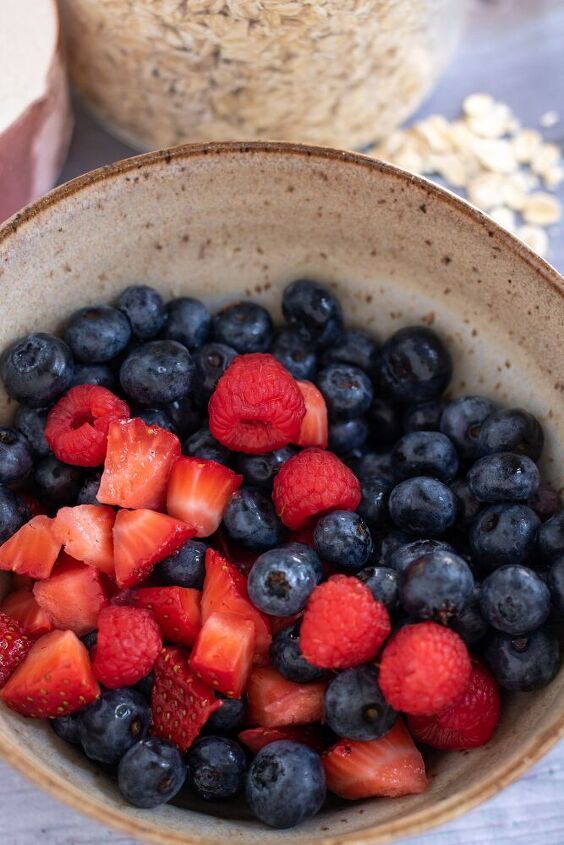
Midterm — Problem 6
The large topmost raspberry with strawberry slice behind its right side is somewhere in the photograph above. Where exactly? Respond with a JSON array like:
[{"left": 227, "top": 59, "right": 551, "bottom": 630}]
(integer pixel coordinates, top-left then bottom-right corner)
[{"left": 208, "top": 352, "right": 305, "bottom": 454}]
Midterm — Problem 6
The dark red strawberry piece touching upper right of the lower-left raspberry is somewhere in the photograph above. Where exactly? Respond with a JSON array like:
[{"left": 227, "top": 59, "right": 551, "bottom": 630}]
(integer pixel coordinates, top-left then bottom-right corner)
[{"left": 134, "top": 587, "right": 202, "bottom": 646}]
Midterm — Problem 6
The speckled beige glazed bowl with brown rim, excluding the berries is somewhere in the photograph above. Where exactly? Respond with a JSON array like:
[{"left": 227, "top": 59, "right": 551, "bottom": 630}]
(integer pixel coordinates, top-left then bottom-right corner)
[{"left": 0, "top": 144, "right": 564, "bottom": 845}]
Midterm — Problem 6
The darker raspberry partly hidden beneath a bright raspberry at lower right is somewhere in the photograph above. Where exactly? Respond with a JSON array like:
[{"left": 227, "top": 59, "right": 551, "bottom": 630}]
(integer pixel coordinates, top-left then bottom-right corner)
[{"left": 408, "top": 660, "right": 501, "bottom": 751}]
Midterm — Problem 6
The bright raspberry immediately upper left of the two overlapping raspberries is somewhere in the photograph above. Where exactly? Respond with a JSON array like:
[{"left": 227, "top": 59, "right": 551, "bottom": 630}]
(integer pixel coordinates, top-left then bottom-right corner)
[{"left": 300, "top": 575, "right": 390, "bottom": 669}]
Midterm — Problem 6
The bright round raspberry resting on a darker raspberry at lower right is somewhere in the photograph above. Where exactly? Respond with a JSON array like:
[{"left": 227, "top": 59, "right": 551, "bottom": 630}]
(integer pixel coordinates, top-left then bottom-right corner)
[{"left": 380, "top": 622, "right": 472, "bottom": 716}]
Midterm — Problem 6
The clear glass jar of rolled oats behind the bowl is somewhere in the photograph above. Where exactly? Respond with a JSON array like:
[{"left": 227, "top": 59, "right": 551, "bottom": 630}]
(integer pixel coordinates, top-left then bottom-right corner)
[{"left": 60, "top": 0, "right": 464, "bottom": 149}]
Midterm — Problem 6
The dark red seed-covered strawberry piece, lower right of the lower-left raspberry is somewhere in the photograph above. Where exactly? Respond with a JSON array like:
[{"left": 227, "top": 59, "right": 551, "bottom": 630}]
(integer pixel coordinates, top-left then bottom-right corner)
[{"left": 151, "top": 648, "right": 223, "bottom": 752}]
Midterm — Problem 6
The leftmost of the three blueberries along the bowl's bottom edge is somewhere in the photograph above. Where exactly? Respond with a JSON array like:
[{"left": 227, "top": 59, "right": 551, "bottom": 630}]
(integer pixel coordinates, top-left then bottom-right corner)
[{"left": 118, "top": 737, "right": 186, "bottom": 810}]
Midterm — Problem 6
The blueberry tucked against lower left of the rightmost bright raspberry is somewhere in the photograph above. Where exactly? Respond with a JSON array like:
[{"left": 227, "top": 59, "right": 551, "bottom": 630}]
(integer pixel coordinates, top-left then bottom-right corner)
[{"left": 324, "top": 665, "right": 397, "bottom": 742}]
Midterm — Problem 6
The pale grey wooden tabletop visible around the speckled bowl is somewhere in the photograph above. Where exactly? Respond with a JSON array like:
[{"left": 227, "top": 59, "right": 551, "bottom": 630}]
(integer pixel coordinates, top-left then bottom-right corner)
[{"left": 0, "top": 0, "right": 564, "bottom": 845}]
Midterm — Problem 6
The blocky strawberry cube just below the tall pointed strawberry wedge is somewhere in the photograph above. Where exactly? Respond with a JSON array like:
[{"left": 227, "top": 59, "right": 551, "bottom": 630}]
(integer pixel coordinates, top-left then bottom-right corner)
[{"left": 190, "top": 613, "right": 255, "bottom": 698}]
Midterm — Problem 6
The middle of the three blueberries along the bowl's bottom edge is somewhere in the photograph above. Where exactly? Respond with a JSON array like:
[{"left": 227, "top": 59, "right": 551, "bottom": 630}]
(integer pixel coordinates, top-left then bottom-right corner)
[{"left": 187, "top": 736, "right": 247, "bottom": 800}]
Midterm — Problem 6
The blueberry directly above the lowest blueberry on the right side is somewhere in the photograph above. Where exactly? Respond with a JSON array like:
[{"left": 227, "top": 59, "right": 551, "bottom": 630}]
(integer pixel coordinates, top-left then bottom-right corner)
[{"left": 480, "top": 564, "right": 550, "bottom": 636}]
